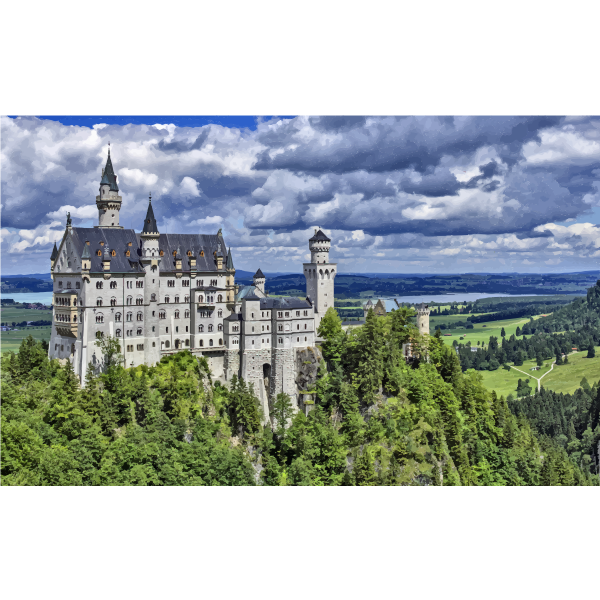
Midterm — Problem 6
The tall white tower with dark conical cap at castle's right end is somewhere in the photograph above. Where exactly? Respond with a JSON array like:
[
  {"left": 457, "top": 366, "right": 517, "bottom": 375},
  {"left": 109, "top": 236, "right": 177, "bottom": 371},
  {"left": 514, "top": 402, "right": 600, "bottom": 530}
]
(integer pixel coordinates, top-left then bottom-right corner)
[{"left": 303, "top": 229, "right": 337, "bottom": 329}]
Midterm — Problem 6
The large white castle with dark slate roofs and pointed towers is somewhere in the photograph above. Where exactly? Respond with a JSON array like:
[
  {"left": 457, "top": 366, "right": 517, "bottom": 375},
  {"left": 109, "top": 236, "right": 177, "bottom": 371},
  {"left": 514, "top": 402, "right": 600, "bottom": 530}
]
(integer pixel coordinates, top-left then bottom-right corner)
[{"left": 48, "top": 149, "right": 337, "bottom": 414}]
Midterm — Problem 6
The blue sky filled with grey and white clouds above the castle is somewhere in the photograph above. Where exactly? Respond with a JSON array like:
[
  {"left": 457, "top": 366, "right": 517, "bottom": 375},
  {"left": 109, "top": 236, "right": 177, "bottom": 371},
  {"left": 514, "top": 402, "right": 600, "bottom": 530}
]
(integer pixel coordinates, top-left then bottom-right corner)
[{"left": 0, "top": 115, "right": 600, "bottom": 275}]
